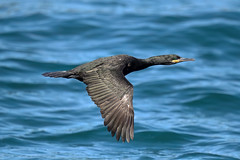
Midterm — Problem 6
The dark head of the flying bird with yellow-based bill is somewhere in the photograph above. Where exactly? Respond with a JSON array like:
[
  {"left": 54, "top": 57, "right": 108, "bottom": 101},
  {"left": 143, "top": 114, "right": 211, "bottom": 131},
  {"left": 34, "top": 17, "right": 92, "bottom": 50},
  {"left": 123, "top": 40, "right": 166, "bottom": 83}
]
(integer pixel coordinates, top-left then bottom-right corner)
[{"left": 147, "top": 54, "right": 195, "bottom": 65}]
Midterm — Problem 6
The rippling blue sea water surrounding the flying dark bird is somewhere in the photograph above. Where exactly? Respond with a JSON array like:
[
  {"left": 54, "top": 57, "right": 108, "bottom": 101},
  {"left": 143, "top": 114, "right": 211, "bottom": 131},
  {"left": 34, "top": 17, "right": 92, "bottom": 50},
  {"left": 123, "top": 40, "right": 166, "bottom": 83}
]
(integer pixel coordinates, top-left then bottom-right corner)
[{"left": 0, "top": 0, "right": 240, "bottom": 160}]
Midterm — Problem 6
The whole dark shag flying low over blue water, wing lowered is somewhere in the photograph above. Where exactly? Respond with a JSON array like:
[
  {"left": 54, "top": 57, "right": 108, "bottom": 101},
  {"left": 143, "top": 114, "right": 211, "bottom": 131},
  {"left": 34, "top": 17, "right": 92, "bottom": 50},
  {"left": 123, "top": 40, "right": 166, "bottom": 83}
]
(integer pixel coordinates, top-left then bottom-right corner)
[{"left": 43, "top": 54, "right": 194, "bottom": 142}]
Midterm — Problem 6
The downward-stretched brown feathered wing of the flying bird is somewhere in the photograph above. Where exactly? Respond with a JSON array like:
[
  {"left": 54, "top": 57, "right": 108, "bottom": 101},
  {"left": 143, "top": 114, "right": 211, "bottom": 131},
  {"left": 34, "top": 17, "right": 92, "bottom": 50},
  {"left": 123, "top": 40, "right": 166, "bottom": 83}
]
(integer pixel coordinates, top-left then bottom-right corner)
[{"left": 83, "top": 68, "right": 134, "bottom": 142}]
